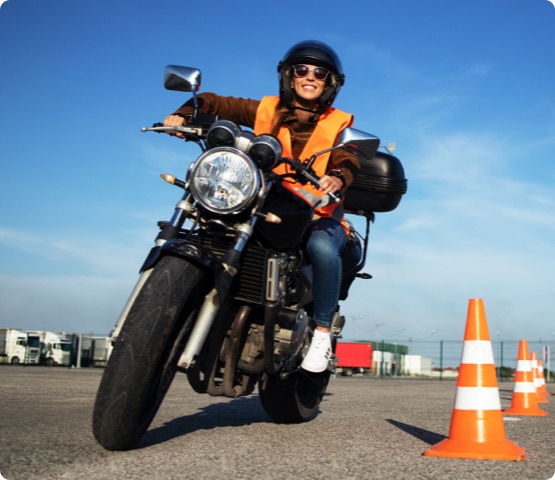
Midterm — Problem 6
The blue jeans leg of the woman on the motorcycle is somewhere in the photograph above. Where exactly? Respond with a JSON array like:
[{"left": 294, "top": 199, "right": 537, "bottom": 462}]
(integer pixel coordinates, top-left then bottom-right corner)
[{"left": 306, "top": 218, "right": 347, "bottom": 327}]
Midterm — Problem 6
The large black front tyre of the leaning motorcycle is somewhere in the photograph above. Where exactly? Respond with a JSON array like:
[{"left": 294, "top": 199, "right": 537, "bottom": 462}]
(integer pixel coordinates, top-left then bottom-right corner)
[{"left": 93, "top": 256, "right": 207, "bottom": 450}]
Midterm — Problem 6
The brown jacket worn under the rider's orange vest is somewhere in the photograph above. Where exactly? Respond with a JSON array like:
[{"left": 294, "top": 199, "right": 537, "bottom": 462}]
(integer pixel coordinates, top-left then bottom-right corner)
[{"left": 174, "top": 93, "right": 360, "bottom": 192}]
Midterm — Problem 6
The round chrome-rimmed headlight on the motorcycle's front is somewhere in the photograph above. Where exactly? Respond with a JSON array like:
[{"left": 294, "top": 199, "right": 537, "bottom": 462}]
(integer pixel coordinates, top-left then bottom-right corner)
[{"left": 189, "top": 147, "right": 261, "bottom": 213}]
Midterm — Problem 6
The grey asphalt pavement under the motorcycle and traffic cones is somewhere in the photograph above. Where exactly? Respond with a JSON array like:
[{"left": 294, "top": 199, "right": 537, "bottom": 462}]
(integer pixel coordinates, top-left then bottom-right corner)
[{"left": 0, "top": 365, "right": 555, "bottom": 480}]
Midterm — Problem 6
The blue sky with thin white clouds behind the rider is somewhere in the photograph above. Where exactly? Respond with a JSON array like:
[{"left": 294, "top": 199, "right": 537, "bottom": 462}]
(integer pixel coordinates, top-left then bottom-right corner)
[{"left": 0, "top": 0, "right": 555, "bottom": 343}]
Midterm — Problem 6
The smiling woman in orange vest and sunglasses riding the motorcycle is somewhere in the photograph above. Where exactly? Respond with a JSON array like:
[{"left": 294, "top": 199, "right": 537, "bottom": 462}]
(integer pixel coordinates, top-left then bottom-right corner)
[{"left": 164, "top": 40, "right": 360, "bottom": 373}]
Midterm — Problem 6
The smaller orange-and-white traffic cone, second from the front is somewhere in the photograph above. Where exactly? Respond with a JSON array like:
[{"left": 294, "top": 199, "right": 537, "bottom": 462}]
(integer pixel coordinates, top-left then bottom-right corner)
[{"left": 503, "top": 340, "right": 547, "bottom": 417}]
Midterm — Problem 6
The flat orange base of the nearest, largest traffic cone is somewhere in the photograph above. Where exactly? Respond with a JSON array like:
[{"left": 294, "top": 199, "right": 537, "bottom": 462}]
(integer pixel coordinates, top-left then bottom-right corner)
[{"left": 422, "top": 438, "right": 526, "bottom": 462}]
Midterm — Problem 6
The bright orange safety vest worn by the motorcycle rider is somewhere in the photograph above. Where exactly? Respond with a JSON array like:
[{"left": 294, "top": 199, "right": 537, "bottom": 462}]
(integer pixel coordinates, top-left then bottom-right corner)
[{"left": 254, "top": 97, "right": 353, "bottom": 228}]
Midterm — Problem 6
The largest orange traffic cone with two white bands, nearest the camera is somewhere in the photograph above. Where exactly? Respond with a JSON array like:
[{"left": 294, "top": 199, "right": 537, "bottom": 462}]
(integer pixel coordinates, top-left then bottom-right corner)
[{"left": 423, "top": 299, "right": 526, "bottom": 460}]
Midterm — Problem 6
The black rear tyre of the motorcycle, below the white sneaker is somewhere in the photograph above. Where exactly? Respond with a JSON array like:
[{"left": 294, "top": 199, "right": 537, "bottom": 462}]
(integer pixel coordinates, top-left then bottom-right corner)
[{"left": 258, "top": 370, "right": 330, "bottom": 423}]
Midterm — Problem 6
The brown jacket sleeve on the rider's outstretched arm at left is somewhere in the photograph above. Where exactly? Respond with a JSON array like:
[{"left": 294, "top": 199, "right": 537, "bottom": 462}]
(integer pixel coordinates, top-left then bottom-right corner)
[{"left": 174, "top": 93, "right": 260, "bottom": 128}]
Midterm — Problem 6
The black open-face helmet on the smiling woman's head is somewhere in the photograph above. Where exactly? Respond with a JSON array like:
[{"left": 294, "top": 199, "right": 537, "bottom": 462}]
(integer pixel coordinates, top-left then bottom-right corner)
[{"left": 278, "top": 40, "right": 345, "bottom": 113}]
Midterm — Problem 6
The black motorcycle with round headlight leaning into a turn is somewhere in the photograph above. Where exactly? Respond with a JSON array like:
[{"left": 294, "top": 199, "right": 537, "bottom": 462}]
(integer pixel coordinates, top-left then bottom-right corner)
[{"left": 93, "top": 65, "right": 406, "bottom": 450}]
